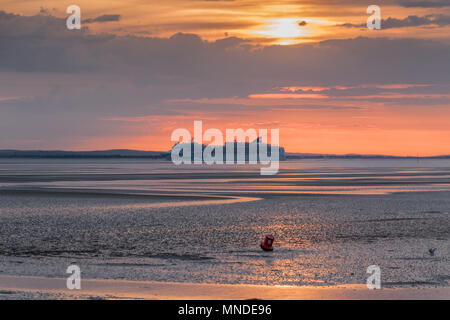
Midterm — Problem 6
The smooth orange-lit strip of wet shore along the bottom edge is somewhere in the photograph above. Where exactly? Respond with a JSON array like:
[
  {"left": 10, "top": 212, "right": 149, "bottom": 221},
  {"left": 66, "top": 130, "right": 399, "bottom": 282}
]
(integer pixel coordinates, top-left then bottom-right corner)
[{"left": 0, "top": 275, "right": 450, "bottom": 300}]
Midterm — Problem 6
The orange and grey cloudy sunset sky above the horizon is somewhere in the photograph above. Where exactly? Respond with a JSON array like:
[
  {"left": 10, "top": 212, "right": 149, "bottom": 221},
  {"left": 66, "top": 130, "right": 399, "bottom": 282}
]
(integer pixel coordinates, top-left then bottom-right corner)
[{"left": 0, "top": 0, "right": 450, "bottom": 156}]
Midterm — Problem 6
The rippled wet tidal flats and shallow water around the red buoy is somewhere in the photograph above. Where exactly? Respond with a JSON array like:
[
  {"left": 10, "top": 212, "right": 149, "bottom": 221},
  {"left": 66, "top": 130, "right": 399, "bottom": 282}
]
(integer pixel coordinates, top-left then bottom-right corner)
[{"left": 0, "top": 159, "right": 450, "bottom": 286}]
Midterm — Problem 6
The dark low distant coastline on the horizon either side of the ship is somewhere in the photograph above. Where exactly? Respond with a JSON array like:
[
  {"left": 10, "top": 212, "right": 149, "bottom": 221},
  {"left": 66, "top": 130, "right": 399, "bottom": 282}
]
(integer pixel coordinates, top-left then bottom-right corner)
[{"left": 0, "top": 149, "right": 450, "bottom": 160}]
